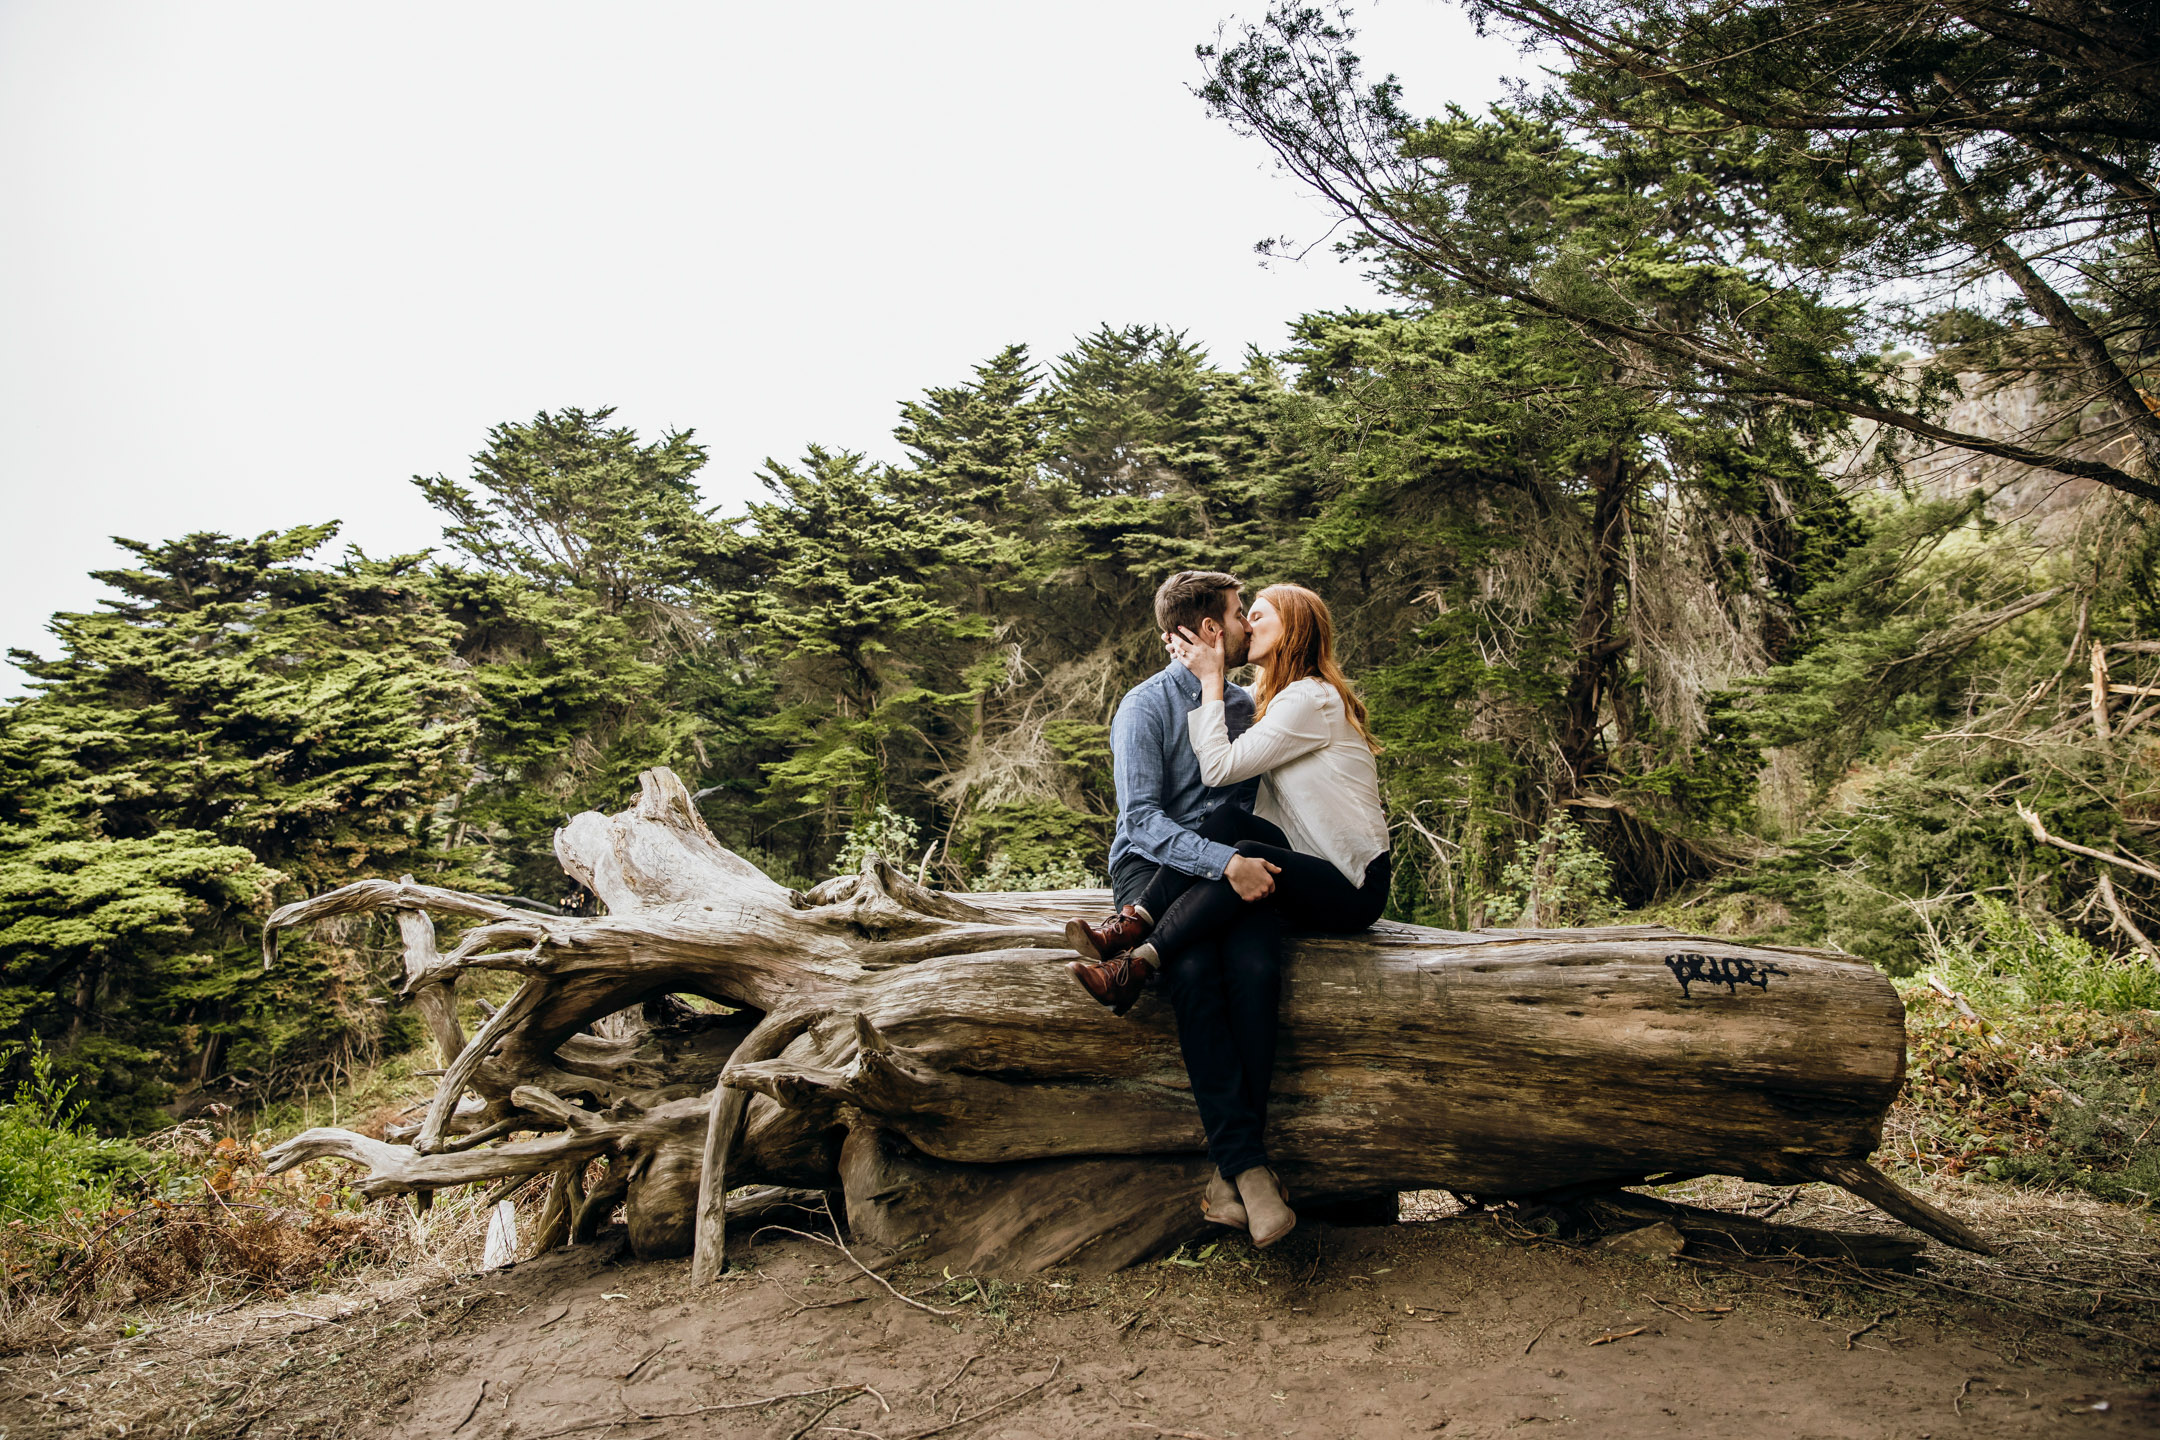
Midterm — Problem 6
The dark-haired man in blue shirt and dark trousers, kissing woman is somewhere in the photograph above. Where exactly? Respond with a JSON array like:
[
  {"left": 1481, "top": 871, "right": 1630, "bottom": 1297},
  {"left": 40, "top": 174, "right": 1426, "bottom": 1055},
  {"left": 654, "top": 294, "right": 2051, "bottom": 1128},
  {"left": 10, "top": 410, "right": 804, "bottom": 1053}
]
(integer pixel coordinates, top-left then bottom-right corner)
[{"left": 1065, "top": 570, "right": 1296, "bottom": 1244}]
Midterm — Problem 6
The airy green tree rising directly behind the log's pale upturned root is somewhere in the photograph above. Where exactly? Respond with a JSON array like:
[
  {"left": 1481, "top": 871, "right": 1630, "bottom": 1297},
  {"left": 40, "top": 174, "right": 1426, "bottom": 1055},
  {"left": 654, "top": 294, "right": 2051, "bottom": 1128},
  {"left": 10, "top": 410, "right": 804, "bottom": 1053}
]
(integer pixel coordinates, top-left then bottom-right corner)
[{"left": 415, "top": 408, "right": 743, "bottom": 900}]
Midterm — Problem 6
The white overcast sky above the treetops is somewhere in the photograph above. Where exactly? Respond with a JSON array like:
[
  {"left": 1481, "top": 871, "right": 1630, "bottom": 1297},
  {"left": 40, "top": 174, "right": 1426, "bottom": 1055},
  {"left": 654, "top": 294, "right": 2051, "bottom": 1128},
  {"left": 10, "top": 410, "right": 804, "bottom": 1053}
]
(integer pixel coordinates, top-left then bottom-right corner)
[{"left": 0, "top": 0, "right": 1523, "bottom": 693}]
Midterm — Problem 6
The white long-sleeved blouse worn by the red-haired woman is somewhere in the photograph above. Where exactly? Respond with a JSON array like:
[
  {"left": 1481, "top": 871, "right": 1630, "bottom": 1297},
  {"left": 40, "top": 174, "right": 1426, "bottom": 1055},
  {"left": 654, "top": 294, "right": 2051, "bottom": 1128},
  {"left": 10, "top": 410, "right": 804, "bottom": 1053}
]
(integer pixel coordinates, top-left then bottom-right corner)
[{"left": 1186, "top": 678, "right": 1387, "bottom": 885}]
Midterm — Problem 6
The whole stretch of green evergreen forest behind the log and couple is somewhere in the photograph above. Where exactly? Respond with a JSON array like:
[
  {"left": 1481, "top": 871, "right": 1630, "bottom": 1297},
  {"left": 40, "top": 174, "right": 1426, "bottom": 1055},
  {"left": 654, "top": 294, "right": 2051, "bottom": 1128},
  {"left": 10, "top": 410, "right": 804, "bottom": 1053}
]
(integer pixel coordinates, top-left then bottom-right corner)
[{"left": 0, "top": 0, "right": 2160, "bottom": 1129}]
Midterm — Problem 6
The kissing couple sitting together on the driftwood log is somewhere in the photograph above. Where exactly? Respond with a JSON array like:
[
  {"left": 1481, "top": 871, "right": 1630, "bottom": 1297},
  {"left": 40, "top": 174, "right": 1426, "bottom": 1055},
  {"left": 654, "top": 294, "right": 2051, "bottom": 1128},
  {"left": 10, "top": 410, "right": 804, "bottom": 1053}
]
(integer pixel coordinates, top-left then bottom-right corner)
[{"left": 1065, "top": 570, "right": 1391, "bottom": 1248}]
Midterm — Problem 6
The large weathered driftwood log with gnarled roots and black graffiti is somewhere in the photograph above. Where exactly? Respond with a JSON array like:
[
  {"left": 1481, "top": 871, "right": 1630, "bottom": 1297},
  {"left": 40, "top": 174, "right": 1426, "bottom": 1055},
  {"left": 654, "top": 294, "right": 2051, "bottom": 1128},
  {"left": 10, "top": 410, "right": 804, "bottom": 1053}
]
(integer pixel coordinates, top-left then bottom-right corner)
[{"left": 264, "top": 771, "right": 1985, "bottom": 1276}]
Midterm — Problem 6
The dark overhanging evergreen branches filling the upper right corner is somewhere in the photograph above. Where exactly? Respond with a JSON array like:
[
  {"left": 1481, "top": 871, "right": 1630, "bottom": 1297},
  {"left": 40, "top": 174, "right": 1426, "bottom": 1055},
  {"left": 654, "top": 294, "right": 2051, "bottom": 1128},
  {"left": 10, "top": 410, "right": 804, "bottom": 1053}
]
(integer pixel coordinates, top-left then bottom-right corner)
[{"left": 1201, "top": 0, "right": 2160, "bottom": 499}]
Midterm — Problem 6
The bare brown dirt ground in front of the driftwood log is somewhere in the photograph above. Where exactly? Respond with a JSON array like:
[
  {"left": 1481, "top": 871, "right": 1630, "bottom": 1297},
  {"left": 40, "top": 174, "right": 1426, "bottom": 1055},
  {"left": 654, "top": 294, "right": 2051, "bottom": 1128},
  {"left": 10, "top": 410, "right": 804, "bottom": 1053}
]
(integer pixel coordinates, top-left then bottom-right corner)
[{"left": 0, "top": 1181, "right": 2160, "bottom": 1440}]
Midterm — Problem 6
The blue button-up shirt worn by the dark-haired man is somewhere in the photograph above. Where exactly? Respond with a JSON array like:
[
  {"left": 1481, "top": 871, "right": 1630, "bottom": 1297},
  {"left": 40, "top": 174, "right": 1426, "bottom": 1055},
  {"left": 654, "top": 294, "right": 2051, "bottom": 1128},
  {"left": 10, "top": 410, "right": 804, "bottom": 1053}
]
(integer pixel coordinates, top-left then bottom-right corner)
[{"left": 1110, "top": 661, "right": 1259, "bottom": 881}]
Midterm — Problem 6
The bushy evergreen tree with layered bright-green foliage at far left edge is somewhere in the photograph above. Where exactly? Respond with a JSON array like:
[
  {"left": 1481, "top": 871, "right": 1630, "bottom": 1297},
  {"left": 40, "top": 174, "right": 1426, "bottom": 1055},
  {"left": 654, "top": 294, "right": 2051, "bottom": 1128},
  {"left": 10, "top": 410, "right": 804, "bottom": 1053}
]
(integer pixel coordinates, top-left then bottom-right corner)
[{"left": 0, "top": 525, "right": 471, "bottom": 1125}]
